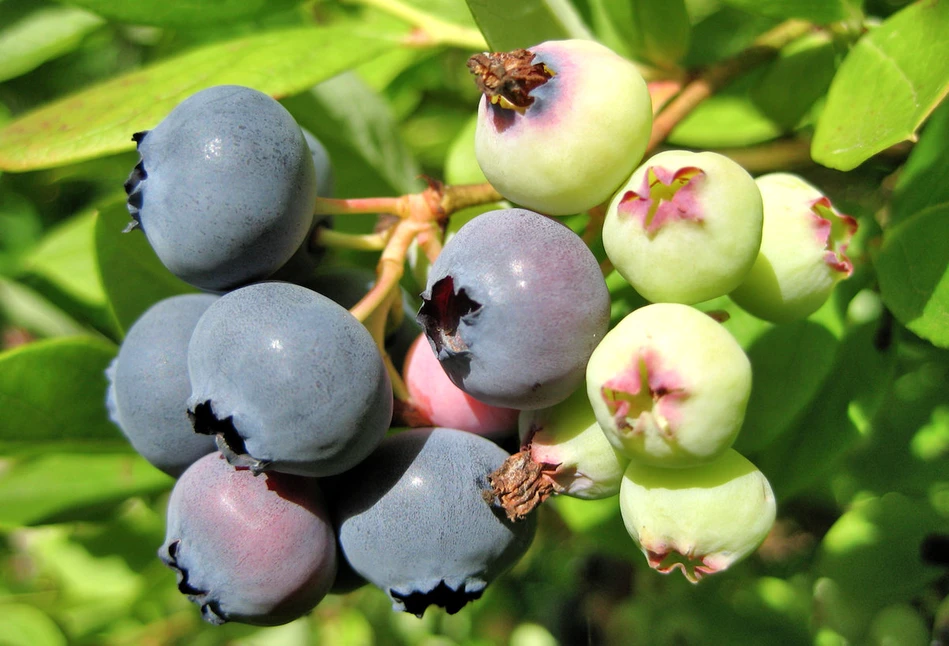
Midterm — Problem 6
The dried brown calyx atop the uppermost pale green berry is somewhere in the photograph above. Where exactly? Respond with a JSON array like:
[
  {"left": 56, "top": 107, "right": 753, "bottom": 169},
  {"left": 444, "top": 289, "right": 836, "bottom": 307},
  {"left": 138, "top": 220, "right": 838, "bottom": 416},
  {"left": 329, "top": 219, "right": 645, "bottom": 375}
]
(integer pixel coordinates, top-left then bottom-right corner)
[{"left": 468, "top": 49, "right": 554, "bottom": 112}]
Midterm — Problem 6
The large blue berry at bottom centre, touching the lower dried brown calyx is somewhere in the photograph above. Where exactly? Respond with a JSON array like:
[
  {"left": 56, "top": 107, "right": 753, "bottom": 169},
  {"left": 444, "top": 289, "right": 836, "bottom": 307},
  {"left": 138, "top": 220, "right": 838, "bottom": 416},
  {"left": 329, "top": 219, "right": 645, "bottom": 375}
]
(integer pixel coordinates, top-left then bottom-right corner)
[{"left": 334, "top": 428, "right": 536, "bottom": 616}]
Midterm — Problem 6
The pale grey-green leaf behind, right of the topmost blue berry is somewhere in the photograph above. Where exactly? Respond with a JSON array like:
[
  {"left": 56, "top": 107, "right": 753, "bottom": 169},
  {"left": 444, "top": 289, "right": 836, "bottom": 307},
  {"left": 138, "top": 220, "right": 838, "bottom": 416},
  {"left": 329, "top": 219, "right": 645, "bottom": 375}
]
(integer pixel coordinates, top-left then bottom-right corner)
[{"left": 284, "top": 73, "right": 422, "bottom": 197}]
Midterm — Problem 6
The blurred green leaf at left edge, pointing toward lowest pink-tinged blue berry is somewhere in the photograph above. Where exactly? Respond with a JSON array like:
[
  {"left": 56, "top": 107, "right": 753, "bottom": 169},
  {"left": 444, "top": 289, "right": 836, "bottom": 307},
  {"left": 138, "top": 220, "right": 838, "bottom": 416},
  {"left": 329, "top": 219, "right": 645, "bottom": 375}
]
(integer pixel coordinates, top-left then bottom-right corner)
[{"left": 0, "top": 453, "right": 173, "bottom": 528}]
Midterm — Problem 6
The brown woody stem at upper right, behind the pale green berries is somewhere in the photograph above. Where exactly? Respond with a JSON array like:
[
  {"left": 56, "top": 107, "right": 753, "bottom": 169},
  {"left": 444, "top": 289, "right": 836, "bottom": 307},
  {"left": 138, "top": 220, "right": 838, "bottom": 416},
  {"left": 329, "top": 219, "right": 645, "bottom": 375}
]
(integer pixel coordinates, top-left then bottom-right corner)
[{"left": 646, "top": 20, "right": 813, "bottom": 154}]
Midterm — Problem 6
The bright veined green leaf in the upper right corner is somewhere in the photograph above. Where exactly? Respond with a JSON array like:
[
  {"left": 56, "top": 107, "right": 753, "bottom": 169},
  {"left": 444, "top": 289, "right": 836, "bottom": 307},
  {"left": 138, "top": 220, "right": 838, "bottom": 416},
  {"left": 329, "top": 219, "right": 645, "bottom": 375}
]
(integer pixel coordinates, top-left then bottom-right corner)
[{"left": 811, "top": 0, "right": 949, "bottom": 170}]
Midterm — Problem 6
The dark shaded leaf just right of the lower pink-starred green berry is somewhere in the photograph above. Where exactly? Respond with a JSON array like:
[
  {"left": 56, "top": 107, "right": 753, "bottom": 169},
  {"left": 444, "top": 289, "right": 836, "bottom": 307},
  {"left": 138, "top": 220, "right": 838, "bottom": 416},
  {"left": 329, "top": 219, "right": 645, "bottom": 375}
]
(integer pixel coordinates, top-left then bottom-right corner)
[{"left": 735, "top": 320, "right": 837, "bottom": 454}]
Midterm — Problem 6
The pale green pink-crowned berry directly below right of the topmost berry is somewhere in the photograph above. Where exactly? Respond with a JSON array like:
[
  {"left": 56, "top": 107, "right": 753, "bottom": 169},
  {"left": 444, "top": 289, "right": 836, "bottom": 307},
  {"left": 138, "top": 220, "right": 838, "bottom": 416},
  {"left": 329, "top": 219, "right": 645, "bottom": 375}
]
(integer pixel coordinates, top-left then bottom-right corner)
[{"left": 603, "top": 150, "right": 762, "bottom": 304}]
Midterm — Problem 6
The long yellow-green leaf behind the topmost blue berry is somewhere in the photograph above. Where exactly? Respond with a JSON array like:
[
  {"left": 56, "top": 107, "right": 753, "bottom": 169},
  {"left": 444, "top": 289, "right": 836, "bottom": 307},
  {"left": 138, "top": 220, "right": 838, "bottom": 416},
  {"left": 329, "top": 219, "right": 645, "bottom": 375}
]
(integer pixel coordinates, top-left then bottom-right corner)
[{"left": 0, "top": 24, "right": 399, "bottom": 171}]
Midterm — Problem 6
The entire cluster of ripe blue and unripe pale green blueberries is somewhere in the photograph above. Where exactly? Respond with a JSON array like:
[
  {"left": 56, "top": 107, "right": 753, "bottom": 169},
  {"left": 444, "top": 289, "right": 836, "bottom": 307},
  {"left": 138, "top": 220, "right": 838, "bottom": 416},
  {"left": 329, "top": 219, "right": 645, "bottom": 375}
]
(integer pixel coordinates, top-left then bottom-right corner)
[{"left": 106, "top": 33, "right": 856, "bottom": 625}]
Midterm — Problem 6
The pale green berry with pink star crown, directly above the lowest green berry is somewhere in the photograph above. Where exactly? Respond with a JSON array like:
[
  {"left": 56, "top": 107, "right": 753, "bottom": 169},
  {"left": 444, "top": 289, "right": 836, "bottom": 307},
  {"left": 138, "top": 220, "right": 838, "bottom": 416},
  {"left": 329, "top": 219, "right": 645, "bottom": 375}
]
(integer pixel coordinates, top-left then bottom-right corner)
[{"left": 587, "top": 303, "right": 751, "bottom": 467}]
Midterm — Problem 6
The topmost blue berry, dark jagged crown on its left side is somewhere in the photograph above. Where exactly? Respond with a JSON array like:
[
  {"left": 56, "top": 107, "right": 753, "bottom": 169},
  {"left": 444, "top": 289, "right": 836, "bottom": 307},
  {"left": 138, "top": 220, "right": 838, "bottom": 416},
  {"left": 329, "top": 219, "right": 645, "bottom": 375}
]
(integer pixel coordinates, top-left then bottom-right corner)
[{"left": 125, "top": 85, "right": 317, "bottom": 291}]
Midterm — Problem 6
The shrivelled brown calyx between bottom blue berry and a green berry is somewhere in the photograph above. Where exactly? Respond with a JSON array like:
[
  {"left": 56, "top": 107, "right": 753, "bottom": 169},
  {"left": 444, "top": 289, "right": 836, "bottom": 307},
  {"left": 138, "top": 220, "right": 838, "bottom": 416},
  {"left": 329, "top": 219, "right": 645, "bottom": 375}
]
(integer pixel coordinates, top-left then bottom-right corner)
[{"left": 488, "top": 445, "right": 563, "bottom": 522}]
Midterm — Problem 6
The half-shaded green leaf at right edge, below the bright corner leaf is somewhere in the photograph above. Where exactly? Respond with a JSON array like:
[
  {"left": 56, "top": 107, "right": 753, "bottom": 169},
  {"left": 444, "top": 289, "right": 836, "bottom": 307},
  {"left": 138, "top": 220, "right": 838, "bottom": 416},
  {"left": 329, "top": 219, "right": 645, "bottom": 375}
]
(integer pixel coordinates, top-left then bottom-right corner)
[{"left": 874, "top": 206, "right": 949, "bottom": 348}]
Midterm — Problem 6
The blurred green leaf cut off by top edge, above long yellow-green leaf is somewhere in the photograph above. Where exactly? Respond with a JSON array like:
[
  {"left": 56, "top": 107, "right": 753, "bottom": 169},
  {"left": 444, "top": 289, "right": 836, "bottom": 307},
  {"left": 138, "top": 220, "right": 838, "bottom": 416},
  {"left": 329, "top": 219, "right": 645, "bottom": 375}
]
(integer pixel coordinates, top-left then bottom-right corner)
[{"left": 52, "top": 0, "right": 297, "bottom": 27}]
